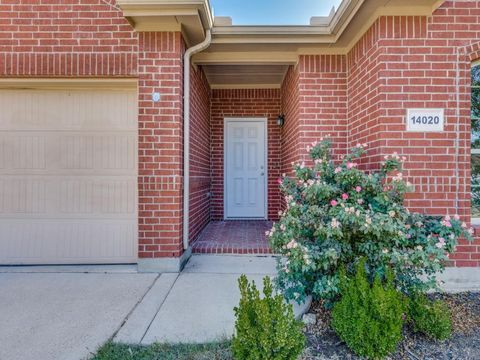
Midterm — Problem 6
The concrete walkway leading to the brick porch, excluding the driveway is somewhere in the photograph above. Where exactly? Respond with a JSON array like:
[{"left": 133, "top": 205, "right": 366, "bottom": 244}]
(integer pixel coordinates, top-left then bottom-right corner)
[{"left": 114, "top": 255, "right": 275, "bottom": 344}]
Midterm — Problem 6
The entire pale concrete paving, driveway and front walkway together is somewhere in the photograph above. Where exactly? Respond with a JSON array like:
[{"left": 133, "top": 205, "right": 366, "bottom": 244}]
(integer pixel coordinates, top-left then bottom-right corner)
[{"left": 0, "top": 255, "right": 275, "bottom": 360}]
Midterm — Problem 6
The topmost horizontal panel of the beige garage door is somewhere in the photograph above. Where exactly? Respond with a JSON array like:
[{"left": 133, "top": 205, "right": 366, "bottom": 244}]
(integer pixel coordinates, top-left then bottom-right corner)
[{"left": 0, "top": 89, "right": 137, "bottom": 131}]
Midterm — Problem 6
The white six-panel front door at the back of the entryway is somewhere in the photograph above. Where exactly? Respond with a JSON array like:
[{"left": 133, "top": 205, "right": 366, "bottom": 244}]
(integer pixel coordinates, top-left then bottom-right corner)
[{"left": 224, "top": 119, "right": 267, "bottom": 219}]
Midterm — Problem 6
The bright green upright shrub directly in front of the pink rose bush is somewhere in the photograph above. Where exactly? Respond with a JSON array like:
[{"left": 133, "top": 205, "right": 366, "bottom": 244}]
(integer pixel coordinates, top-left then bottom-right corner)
[{"left": 332, "top": 260, "right": 406, "bottom": 359}]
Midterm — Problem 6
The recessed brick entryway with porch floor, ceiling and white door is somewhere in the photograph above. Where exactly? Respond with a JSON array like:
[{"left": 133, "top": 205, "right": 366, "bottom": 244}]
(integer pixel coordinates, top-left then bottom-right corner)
[{"left": 189, "top": 64, "right": 286, "bottom": 255}]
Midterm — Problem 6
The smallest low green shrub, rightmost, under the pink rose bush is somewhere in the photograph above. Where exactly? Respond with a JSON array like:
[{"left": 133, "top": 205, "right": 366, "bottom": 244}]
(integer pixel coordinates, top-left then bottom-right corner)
[{"left": 410, "top": 294, "right": 452, "bottom": 341}]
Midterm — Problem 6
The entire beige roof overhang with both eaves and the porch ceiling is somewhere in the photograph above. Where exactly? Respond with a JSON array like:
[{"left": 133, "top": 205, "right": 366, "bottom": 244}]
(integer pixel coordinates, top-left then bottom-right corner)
[{"left": 117, "top": 0, "right": 445, "bottom": 87}]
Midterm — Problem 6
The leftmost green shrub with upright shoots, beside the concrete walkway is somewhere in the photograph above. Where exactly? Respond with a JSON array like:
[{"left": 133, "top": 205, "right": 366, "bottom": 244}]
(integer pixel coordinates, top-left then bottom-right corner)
[{"left": 232, "top": 275, "right": 305, "bottom": 360}]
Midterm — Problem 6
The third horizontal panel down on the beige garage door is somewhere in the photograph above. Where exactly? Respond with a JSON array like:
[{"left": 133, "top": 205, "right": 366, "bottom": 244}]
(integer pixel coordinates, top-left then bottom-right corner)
[{"left": 0, "top": 176, "right": 137, "bottom": 219}]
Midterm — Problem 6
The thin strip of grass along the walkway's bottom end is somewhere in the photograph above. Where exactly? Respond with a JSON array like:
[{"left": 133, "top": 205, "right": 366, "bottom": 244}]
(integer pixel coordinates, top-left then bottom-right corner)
[{"left": 92, "top": 341, "right": 232, "bottom": 360}]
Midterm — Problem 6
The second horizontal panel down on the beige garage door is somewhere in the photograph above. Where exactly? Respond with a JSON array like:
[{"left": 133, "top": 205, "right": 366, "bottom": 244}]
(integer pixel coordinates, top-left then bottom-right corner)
[{"left": 0, "top": 131, "right": 137, "bottom": 175}]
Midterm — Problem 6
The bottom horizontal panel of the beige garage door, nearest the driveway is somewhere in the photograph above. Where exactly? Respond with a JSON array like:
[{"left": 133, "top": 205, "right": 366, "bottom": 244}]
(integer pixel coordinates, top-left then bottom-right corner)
[{"left": 0, "top": 219, "right": 137, "bottom": 264}]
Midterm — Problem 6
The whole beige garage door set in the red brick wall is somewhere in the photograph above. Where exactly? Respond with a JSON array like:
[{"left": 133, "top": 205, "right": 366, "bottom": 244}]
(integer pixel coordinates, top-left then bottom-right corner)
[{"left": 0, "top": 83, "right": 137, "bottom": 264}]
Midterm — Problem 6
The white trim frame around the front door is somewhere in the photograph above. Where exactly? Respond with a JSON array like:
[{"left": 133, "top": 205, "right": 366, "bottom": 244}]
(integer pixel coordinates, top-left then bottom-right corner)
[{"left": 223, "top": 117, "right": 268, "bottom": 220}]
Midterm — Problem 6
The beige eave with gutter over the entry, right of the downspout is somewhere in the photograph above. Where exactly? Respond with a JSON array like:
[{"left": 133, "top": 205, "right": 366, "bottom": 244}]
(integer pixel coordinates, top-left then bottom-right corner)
[{"left": 194, "top": 0, "right": 445, "bottom": 64}]
